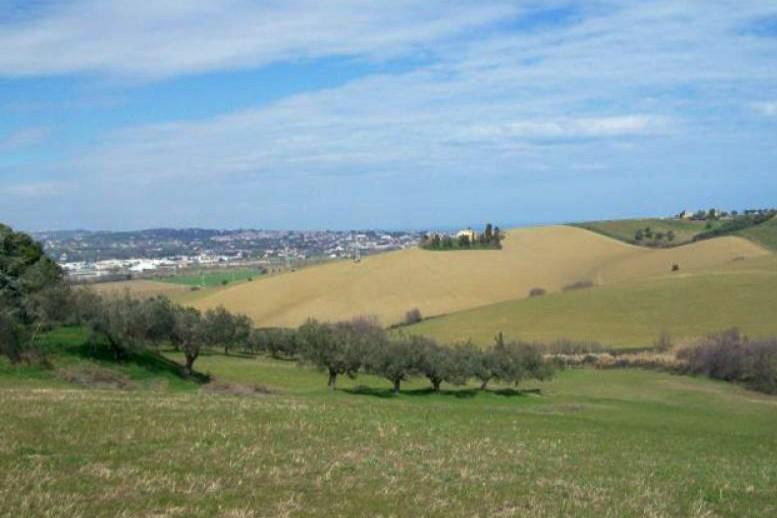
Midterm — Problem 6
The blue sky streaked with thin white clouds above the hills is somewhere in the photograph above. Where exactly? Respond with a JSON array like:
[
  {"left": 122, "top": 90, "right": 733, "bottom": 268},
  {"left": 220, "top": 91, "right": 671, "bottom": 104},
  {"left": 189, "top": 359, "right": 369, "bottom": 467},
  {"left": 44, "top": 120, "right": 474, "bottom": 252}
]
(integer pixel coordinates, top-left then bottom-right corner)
[{"left": 0, "top": 0, "right": 777, "bottom": 231}]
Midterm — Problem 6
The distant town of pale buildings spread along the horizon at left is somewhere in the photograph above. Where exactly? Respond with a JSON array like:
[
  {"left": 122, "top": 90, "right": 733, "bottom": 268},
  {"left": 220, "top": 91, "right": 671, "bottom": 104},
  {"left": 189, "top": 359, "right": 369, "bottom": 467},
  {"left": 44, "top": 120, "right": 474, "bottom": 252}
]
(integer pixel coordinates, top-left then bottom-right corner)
[{"left": 34, "top": 229, "right": 424, "bottom": 282}]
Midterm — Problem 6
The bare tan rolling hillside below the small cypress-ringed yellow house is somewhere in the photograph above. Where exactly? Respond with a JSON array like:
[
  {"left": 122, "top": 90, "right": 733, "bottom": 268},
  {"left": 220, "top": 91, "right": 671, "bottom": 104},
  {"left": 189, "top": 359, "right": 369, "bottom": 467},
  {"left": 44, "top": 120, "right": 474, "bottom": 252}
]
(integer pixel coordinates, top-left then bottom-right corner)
[{"left": 192, "top": 226, "right": 768, "bottom": 326}]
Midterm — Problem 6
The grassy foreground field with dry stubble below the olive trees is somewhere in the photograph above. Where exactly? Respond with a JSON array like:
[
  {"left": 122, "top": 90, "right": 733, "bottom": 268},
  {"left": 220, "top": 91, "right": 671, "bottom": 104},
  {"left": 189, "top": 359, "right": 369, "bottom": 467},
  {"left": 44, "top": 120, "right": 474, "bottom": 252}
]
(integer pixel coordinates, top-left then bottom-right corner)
[{"left": 0, "top": 340, "right": 777, "bottom": 517}]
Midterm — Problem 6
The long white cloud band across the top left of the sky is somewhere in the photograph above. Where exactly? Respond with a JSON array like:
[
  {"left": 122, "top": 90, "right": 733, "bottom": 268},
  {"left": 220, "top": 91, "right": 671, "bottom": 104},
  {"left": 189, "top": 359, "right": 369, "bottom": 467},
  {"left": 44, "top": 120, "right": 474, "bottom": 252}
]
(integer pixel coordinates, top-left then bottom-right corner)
[{"left": 0, "top": 0, "right": 517, "bottom": 78}]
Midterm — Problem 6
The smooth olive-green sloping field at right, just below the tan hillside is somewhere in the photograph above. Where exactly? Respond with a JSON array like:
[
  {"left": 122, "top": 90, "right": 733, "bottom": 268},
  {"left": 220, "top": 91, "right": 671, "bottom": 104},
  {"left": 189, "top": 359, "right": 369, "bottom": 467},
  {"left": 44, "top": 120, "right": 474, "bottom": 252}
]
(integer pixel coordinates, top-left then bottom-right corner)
[{"left": 405, "top": 264, "right": 777, "bottom": 348}]
